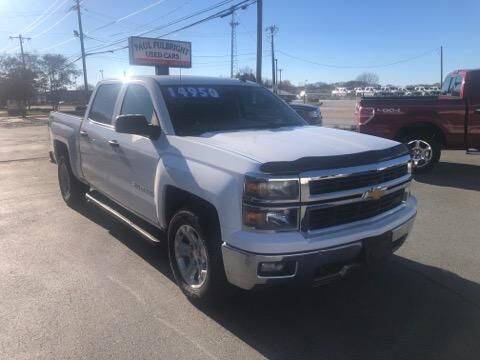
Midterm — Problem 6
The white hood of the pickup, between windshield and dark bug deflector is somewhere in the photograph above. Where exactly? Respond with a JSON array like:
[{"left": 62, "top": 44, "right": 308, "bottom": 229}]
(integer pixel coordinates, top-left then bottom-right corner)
[{"left": 195, "top": 126, "right": 398, "bottom": 163}]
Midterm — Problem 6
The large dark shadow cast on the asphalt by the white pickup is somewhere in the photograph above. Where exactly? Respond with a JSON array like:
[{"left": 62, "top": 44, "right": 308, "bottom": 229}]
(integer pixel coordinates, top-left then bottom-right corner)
[{"left": 75, "top": 207, "right": 480, "bottom": 360}]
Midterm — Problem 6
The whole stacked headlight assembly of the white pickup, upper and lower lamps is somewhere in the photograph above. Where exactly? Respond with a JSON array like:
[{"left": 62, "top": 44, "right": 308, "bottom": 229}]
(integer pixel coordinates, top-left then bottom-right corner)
[{"left": 243, "top": 175, "right": 300, "bottom": 231}]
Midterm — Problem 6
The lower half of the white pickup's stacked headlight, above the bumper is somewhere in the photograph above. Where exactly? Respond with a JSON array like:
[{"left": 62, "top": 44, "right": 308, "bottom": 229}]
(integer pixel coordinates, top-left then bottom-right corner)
[{"left": 243, "top": 205, "right": 299, "bottom": 231}]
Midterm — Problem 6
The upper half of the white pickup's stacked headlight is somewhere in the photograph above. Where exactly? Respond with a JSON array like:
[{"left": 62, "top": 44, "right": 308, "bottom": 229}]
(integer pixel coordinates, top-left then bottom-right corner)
[{"left": 244, "top": 176, "right": 299, "bottom": 202}]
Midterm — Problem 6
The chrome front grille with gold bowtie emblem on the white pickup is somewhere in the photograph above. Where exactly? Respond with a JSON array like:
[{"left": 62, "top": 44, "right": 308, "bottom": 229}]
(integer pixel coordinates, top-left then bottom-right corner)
[{"left": 300, "top": 156, "right": 411, "bottom": 233}]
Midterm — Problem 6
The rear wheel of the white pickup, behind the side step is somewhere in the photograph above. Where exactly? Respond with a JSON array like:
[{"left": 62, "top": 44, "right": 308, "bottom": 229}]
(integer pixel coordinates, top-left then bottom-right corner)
[{"left": 57, "top": 155, "right": 88, "bottom": 208}]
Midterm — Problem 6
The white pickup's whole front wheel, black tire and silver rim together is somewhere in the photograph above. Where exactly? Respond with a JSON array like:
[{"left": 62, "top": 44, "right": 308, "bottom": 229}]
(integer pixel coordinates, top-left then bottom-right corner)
[{"left": 168, "top": 209, "right": 233, "bottom": 304}]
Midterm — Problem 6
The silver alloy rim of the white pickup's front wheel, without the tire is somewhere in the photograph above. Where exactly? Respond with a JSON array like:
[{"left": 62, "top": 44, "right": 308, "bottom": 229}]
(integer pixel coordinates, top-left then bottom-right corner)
[{"left": 174, "top": 225, "right": 208, "bottom": 289}]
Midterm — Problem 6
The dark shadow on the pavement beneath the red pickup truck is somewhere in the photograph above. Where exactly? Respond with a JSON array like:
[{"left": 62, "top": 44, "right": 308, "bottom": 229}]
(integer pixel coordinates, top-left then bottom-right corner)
[{"left": 415, "top": 162, "right": 480, "bottom": 191}]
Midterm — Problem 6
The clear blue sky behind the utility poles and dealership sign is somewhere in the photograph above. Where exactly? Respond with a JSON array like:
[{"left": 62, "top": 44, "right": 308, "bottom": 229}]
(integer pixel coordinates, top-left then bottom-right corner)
[{"left": 0, "top": 0, "right": 480, "bottom": 85}]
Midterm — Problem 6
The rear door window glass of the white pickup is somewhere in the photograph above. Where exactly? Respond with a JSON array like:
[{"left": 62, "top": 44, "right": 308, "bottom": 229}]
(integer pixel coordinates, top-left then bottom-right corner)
[{"left": 88, "top": 84, "right": 121, "bottom": 124}]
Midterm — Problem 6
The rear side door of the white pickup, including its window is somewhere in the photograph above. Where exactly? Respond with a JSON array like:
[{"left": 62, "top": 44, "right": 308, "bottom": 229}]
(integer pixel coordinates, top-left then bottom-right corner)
[{"left": 80, "top": 82, "right": 122, "bottom": 194}]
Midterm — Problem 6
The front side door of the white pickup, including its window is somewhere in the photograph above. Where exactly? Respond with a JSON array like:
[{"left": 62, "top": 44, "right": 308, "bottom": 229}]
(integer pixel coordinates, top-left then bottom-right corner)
[{"left": 107, "top": 81, "right": 160, "bottom": 223}]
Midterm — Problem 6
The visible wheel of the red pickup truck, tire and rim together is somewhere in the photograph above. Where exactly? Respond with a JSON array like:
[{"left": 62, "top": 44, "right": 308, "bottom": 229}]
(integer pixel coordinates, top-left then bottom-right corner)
[{"left": 402, "top": 132, "right": 442, "bottom": 173}]
